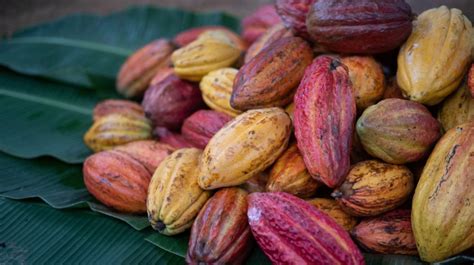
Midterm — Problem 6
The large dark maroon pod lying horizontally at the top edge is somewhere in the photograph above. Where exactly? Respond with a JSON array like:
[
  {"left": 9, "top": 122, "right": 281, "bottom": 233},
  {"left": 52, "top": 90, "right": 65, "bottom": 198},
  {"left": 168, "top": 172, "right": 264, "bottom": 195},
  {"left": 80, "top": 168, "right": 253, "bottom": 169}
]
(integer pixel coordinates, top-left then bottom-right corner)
[{"left": 306, "top": 0, "right": 413, "bottom": 54}]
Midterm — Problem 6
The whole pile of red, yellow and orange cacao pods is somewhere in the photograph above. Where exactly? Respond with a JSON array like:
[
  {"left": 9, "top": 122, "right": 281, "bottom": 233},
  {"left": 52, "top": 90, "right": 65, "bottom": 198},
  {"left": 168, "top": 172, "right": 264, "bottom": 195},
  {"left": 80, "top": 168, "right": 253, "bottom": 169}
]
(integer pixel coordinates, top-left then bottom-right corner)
[{"left": 83, "top": 0, "right": 474, "bottom": 264}]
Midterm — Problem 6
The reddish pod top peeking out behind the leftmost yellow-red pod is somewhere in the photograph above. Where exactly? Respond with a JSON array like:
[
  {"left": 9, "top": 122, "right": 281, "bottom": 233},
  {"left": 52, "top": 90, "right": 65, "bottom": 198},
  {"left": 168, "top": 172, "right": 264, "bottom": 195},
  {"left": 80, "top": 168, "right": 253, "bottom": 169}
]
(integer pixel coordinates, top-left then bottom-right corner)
[{"left": 93, "top": 99, "right": 145, "bottom": 121}]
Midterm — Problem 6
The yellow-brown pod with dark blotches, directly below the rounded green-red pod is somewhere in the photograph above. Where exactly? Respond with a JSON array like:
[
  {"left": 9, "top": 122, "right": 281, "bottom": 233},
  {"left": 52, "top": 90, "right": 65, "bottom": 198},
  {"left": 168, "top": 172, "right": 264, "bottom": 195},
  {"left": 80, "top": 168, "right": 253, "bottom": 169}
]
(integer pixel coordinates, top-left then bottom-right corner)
[{"left": 331, "top": 160, "right": 414, "bottom": 216}]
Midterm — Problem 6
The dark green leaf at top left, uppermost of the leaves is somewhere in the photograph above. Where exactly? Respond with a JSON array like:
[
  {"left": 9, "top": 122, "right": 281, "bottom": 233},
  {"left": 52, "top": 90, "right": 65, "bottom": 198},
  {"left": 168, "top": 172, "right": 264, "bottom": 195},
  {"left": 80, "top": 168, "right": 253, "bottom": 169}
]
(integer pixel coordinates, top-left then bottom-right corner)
[{"left": 0, "top": 6, "right": 239, "bottom": 88}]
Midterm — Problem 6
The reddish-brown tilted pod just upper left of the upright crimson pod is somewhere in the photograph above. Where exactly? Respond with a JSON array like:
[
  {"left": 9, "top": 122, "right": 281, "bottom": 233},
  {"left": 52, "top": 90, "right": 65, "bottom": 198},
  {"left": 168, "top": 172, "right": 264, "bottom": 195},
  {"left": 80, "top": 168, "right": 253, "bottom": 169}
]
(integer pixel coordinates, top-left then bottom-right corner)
[{"left": 230, "top": 37, "right": 313, "bottom": 110}]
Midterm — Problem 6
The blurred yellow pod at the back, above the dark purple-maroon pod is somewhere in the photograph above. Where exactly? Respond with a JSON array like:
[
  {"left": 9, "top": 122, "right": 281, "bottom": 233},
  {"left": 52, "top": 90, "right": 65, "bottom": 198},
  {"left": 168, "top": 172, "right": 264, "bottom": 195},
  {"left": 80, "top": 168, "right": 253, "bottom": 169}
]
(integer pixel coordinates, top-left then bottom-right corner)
[{"left": 171, "top": 30, "right": 240, "bottom": 81}]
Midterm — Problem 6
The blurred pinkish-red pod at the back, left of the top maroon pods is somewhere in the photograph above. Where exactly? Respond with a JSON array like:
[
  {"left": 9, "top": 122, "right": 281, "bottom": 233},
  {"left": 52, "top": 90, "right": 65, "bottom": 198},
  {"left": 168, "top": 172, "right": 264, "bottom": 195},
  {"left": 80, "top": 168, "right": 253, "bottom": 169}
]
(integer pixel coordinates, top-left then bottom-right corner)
[{"left": 241, "top": 5, "right": 281, "bottom": 44}]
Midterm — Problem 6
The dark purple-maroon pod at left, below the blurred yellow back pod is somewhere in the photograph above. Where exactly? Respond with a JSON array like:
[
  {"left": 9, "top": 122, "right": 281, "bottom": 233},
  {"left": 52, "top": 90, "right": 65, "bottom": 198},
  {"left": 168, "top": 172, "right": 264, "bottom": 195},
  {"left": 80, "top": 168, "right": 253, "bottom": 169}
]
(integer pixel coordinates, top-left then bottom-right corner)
[{"left": 142, "top": 75, "right": 204, "bottom": 130}]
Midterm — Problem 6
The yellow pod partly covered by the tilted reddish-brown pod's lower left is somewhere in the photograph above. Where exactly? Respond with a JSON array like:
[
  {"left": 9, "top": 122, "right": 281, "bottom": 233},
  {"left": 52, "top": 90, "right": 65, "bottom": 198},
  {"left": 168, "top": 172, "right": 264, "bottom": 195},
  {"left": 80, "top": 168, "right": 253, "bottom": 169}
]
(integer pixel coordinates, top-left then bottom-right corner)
[{"left": 199, "top": 67, "right": 242, "bottom": 117}]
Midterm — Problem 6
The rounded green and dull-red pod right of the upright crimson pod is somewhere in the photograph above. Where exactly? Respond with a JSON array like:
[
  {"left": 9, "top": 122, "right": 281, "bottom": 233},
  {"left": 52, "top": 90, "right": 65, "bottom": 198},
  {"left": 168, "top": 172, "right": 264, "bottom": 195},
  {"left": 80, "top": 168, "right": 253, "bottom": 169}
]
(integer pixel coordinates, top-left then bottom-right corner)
[{"left": 356, "top": 98, "right": 440, "bottom": 164}]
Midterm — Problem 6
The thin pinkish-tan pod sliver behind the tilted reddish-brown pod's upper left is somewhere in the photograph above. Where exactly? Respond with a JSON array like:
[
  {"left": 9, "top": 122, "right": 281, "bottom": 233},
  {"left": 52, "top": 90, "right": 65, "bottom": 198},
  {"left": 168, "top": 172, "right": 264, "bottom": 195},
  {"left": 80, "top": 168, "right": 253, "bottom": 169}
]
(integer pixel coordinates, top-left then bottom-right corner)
[{"left": 244, "top": 23, "right": 293, "bottom": 63}]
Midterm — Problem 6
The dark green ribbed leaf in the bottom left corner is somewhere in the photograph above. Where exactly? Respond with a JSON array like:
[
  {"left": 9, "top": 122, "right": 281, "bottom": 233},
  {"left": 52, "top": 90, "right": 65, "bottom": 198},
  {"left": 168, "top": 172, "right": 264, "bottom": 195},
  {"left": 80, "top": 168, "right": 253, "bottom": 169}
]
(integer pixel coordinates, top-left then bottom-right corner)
[{"left": 0, "top": 198, "right": 184, "bottom": 264}]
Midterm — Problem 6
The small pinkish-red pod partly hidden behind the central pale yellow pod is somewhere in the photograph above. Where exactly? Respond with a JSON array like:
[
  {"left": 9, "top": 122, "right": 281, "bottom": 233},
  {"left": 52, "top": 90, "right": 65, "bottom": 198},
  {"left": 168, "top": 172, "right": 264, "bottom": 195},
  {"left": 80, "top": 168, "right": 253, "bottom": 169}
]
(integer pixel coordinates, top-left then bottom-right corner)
[{"left": 181, "top": 110, "right": 232, "bottom": 149}]
